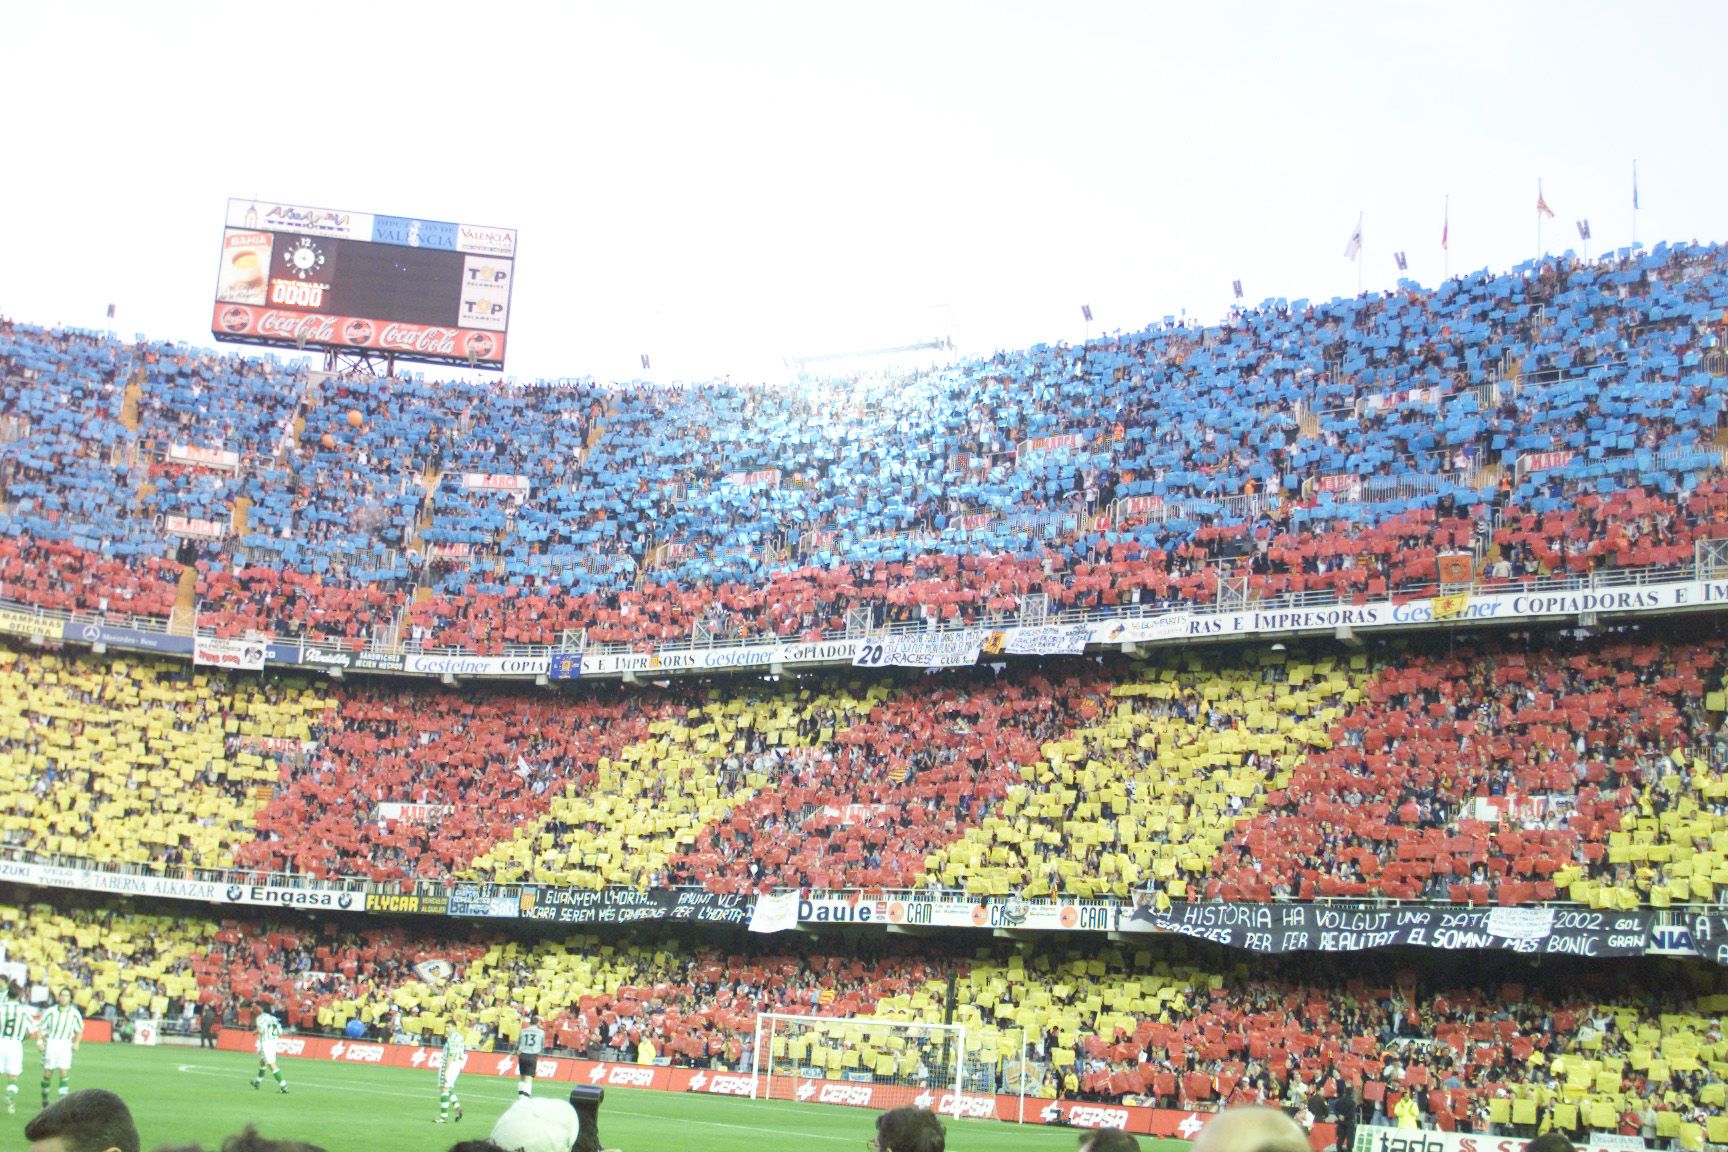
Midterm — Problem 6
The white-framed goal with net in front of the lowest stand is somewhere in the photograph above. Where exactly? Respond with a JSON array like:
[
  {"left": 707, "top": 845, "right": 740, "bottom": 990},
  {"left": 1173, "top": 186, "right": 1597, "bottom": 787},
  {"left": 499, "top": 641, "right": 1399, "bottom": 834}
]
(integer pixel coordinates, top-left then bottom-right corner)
[{"left": 752, "top": 1012, "right": 1020, "bottom": 1116}]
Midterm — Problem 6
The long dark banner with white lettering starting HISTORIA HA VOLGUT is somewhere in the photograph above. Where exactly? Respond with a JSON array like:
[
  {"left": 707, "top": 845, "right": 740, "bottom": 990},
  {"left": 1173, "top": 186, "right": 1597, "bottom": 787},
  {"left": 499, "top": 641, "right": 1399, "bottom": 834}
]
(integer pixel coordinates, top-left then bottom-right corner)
[{"left": 1121, "top": 902, "right": 1654, "bottom": 957}]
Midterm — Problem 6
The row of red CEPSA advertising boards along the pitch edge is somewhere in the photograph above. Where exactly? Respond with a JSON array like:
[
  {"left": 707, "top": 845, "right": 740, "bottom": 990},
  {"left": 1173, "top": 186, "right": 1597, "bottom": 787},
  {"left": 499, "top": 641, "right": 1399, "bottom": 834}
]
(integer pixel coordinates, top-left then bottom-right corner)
[{"left": 216, "top": 1028, "right": 1320, "bottom": 1152}]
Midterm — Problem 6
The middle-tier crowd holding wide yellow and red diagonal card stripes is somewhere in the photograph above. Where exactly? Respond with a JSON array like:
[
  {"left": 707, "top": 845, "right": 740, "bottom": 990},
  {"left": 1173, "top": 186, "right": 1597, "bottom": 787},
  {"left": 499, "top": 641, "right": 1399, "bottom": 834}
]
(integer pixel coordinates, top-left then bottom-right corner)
[{"left": 0, "top": 634, "right": 1728, "bottom": 907}]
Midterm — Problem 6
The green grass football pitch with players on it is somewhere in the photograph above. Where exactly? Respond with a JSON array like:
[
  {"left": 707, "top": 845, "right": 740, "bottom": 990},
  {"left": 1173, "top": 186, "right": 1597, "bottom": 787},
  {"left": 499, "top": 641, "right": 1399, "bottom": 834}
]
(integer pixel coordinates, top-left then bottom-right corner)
[{"left": 13, "top": 1045, "right": 1187, "bottom": 1152}]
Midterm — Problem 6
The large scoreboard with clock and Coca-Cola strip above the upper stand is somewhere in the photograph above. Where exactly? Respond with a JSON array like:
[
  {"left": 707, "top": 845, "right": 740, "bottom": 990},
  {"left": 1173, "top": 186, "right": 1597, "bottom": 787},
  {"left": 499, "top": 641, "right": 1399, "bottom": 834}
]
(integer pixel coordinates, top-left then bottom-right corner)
[{"left": 211, "top": 200, "right": 517, "bottom": 370}]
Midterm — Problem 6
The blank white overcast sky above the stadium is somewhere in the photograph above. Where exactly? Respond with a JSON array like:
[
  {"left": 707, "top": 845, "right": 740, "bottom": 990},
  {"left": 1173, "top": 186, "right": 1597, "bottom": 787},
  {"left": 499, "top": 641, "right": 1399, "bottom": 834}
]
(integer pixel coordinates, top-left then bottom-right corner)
[{"left": 0, "top": 0, "right": 1728, "bottom": 378}]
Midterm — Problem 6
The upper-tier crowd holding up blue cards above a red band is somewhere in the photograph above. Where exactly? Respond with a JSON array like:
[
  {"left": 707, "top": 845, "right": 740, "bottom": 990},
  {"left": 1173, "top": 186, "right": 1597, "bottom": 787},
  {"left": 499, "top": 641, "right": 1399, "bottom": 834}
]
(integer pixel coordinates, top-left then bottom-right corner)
[{"left": 0, "top": 245, "right": 1728, "bottom": 651}]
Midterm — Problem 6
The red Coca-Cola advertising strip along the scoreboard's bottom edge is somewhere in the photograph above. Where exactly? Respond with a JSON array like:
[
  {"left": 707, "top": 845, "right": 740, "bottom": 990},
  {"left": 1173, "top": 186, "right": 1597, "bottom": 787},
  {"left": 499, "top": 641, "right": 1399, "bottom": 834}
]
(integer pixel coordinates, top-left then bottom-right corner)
[{"left": 211, "top": 304, "right": 505, "bottom": 368}]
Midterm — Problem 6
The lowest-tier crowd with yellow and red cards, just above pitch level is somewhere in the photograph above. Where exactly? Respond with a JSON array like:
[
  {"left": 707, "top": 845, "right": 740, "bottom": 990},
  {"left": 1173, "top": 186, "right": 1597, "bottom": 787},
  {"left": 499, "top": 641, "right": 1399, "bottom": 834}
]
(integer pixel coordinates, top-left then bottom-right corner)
[{"left": 20, "top": 903, "right": 1728, "bottom": 1149}]
